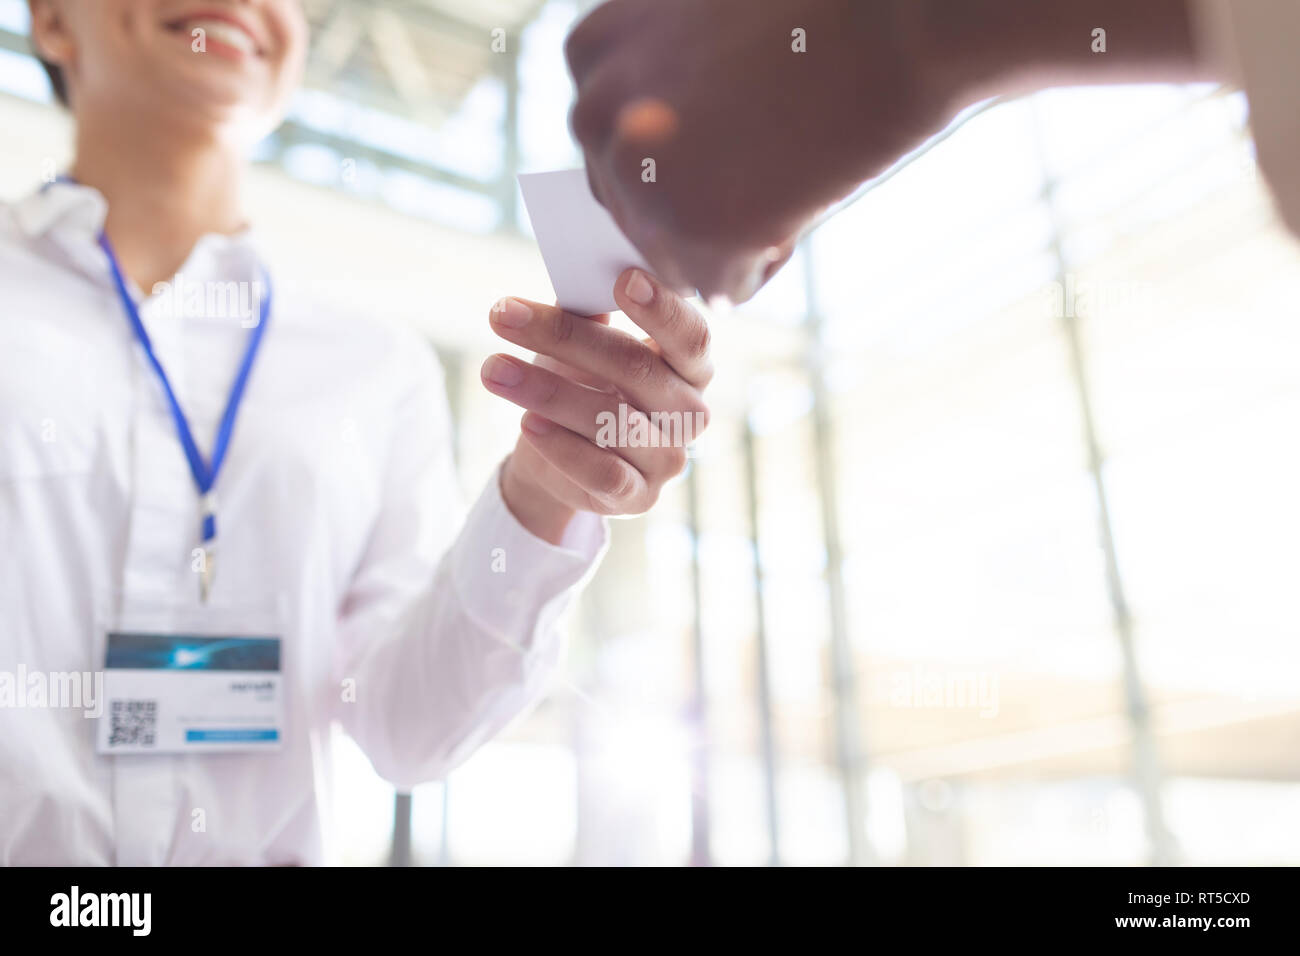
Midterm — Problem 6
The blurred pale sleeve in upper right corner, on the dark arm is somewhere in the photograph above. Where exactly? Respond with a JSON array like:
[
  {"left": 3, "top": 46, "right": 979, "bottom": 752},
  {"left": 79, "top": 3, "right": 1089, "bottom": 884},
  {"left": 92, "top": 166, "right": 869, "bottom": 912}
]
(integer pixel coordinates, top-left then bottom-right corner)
[{"left": 1193, "top": 0, "right": 1300, "bottom": 237}]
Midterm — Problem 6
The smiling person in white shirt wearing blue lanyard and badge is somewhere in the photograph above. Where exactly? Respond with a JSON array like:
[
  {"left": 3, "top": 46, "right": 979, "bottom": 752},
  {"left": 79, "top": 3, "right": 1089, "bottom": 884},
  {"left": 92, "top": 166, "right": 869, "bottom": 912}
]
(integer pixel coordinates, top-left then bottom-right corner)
[{"left": 0, "top": 0, "right": 710, "bottom": 865}]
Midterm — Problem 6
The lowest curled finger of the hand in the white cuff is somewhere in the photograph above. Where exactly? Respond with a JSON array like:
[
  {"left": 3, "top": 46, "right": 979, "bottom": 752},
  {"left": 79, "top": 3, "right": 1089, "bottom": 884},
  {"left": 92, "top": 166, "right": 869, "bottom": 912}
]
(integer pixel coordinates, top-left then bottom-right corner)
[{"left": 521, "top": 412, "right": 658, "bottom": 515}]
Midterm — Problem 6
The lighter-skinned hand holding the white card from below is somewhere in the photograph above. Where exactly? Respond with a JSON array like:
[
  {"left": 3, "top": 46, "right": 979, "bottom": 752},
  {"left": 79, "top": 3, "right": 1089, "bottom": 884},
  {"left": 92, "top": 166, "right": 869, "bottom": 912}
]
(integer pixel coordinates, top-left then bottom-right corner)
[{"left": 482, "top": 268, "right": 712, "bottom": 544}]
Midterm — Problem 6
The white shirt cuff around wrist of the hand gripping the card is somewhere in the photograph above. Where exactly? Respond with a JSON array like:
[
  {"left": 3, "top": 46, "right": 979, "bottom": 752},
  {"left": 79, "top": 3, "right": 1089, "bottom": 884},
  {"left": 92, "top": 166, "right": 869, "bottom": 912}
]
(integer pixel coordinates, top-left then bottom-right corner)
[{"left": 450, "top": 468, "right": 610, "bottom": 649}]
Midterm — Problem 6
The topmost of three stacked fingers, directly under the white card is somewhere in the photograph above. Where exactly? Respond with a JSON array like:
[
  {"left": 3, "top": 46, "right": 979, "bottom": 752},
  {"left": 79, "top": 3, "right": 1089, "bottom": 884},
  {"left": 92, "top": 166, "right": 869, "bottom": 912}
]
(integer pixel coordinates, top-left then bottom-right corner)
[{"left": 491, "top": 299, "right": 707, "bottom": 415}]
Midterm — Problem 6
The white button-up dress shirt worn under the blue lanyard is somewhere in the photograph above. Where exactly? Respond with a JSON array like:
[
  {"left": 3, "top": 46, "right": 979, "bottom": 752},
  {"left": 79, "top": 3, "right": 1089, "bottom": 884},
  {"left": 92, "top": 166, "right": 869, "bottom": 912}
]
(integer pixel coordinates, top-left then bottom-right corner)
[{"left": 0, "top": 182, "right": 606, "bottom": 865}]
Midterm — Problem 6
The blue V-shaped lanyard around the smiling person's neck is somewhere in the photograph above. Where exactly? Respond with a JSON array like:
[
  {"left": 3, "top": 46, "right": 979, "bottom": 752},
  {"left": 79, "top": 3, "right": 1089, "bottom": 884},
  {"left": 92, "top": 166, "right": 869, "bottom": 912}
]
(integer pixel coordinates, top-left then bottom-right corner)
[{"left": 99, "top": 233, "right": 270, "bottom": 544}]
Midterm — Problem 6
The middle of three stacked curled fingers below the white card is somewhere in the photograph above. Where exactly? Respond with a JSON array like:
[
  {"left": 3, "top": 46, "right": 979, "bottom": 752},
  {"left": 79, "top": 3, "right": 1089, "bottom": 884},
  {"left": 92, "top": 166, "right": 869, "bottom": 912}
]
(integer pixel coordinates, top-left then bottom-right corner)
[{"left": 482, "top": 355, "right": 685, "bottom": 481}]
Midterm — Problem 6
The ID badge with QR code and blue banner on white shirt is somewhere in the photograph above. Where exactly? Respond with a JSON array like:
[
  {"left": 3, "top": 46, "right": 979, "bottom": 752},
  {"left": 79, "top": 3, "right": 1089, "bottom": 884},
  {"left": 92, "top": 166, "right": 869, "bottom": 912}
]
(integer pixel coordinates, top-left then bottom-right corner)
[{"left": 96, "top": 590, "right": 285, "bottom": 754}]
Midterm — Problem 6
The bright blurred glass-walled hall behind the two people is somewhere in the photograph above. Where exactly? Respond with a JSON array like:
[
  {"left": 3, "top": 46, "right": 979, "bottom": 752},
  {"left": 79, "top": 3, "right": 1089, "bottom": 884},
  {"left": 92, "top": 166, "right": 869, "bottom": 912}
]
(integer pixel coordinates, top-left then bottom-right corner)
[{"left": 0, "top": 0, "right": 1300, "bottom": 865}]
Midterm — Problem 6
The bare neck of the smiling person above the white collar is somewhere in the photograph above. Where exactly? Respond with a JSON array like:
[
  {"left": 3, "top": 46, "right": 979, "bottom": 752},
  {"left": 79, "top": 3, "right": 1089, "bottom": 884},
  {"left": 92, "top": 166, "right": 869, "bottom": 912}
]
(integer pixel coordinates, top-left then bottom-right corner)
[{"left": 72, "top": 109, "right": 244, "bottom": 294}]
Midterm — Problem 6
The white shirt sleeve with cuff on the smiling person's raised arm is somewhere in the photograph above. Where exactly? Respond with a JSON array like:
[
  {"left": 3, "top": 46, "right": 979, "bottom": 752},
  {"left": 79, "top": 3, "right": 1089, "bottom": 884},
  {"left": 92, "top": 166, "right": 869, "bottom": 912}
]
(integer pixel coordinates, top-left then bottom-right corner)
[{"left": 327, "top": 335, "right": 608, "bottom": 788}]
